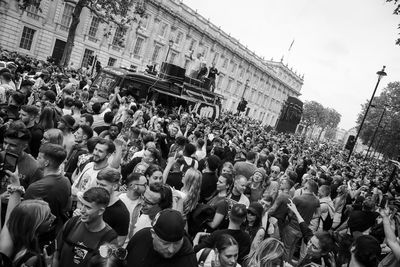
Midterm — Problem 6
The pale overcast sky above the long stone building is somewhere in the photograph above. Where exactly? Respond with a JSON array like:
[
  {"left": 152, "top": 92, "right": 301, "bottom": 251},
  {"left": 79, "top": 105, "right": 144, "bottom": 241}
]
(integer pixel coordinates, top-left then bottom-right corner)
[{"left": 183, "top": 0, "right": 400, "bottom": 130}]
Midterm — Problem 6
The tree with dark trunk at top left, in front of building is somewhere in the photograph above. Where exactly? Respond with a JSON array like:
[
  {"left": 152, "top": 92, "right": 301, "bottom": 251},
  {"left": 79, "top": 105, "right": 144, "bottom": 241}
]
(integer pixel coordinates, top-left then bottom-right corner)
[{"left": 16, "top": 0, "right": 146, "bottom": 67}]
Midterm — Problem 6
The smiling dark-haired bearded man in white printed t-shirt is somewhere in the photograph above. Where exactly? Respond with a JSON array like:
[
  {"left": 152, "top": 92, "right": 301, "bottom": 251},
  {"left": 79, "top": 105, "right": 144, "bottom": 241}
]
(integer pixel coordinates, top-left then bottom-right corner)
[{"left": 72, "top": 139, "right": 115, "bottom": 200}]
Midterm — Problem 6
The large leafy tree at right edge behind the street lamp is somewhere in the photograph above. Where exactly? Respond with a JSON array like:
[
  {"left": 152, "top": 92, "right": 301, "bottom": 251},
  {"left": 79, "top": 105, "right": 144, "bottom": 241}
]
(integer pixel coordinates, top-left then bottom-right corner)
[{"left": 357, "top": 82, "right": 400, "bottom": 158}]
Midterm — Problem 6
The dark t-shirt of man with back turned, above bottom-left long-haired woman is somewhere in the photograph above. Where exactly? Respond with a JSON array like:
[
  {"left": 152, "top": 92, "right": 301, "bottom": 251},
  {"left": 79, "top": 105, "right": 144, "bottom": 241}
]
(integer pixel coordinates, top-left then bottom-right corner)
[{"left": 24, "top": 174, "right": 71, "bottom": 221}]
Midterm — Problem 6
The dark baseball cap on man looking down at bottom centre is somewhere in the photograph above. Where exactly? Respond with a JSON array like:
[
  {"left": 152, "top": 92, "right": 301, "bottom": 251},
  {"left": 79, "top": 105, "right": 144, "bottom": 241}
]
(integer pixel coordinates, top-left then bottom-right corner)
[{"left": 153, "top": 209, "right": 185, "bottom": 242}]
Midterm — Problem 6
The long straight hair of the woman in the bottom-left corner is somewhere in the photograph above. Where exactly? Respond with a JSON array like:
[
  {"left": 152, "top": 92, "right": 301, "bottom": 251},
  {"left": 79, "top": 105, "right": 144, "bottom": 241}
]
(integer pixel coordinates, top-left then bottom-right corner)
[{"left": 7, "top": 200, "right": 51, "bottom": 262}]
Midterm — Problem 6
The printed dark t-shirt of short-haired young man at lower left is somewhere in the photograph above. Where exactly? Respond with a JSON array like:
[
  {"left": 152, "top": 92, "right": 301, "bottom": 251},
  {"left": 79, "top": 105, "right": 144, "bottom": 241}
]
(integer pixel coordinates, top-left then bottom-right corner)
[{"left": 57, "top": 218, "right": 117, "bottom": 267}]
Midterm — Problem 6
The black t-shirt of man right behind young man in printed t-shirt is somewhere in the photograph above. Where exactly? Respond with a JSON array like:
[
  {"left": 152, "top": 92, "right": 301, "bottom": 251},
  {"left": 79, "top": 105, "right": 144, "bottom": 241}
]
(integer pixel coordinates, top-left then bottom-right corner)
[{"left": 103, "top": 199, "right": 129, "bottom": 236}]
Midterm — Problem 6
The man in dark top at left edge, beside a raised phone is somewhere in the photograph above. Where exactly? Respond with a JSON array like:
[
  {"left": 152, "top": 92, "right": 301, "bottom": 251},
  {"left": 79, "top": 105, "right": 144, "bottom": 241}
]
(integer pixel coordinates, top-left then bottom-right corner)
[{"left": 0, "top": 121, "right": 43, "bottom": 189}]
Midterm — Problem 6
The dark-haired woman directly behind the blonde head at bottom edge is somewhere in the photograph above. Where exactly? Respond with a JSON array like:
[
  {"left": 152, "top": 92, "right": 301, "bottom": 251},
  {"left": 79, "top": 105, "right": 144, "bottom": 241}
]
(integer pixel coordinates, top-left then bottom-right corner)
[{"left": 244, "top": 202, "right": 265, "bottom": 251}]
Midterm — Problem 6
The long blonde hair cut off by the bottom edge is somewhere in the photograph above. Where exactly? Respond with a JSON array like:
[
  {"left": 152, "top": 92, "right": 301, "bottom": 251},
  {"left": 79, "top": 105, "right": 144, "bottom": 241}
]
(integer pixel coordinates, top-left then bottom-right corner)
[{"left": 246, "top": 237, "right": 284, "bottom": 267}]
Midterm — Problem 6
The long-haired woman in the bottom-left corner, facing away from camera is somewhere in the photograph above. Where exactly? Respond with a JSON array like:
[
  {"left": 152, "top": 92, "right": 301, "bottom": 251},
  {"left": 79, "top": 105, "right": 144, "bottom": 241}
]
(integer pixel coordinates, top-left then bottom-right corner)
[{"left": 0, "top": 200, "right": 55, "bottom": 267}]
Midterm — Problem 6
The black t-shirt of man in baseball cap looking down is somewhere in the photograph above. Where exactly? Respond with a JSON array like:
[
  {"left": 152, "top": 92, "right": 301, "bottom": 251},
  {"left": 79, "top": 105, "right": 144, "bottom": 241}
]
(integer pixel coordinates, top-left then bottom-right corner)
[{"left": 126, "top": 228, "right": 197, "bottom": 267}]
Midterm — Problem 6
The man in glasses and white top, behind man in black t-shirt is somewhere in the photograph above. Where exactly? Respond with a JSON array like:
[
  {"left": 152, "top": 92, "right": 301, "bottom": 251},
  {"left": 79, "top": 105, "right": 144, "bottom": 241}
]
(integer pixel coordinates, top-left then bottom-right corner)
[{"left": 119, "top": 173, "right": 147, "bottom": 247}]
